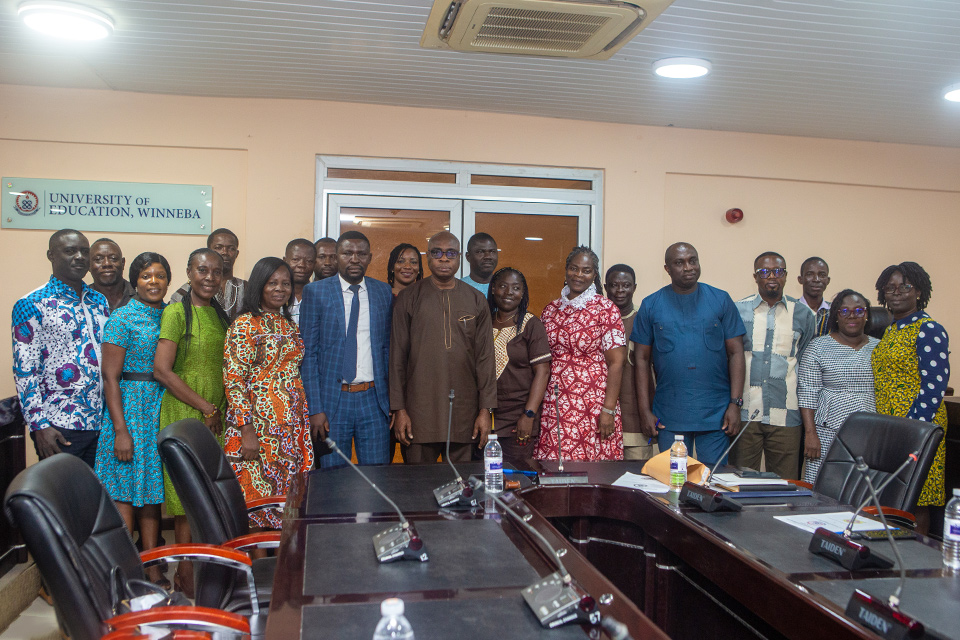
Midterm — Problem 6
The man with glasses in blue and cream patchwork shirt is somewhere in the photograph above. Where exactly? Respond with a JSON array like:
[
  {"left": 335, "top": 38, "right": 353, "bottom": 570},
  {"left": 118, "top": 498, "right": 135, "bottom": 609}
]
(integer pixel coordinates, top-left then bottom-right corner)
[{"left": 730, "top": 251, "right": 816, "bottom": 479}]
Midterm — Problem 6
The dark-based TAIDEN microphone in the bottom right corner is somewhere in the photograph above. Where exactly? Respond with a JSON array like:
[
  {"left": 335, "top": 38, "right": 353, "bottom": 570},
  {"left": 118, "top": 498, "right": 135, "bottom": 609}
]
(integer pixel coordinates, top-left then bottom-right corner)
[{"left": 846, "top": 456, "right": 925, "bottom": 640}]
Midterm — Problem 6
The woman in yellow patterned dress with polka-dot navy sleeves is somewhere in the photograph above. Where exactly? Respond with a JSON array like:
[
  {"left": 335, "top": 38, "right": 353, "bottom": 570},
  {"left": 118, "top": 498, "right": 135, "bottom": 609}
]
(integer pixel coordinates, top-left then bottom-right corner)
[{"left": 872, "top": 262, "right": 950, "bottom": 533}]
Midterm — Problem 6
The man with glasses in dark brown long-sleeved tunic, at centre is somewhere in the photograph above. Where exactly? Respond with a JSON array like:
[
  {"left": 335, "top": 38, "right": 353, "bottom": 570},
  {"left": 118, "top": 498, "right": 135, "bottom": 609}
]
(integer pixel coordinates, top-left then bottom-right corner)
[{"left": 390, "top": 231, "right": 497, "bottom": 464}]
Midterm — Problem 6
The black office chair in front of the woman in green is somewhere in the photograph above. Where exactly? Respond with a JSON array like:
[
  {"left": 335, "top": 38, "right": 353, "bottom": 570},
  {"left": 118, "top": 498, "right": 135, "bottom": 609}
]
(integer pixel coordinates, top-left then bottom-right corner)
[{"left": 157, "top": 419, "right": 286, "bottom": 613}]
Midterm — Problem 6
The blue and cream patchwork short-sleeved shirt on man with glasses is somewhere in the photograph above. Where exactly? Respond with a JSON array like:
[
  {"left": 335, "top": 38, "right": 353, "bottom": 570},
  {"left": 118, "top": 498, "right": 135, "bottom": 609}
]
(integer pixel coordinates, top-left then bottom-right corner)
[{"left": 737, "top": 293, "right": 816, "bottom": 427}]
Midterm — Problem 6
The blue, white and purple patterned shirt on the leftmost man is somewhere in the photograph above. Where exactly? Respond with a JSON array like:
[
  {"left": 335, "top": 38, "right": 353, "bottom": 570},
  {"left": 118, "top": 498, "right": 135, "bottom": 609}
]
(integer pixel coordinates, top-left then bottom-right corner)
[{"left": 13, "top": 276, "right": 110, "bottom": 431}]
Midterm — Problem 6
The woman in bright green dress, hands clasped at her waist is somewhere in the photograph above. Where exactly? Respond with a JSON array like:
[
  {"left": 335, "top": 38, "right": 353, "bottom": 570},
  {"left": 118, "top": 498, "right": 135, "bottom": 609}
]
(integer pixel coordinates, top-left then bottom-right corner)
[{"left": 153, "top": 249, "right": 230, "bottom": 597}]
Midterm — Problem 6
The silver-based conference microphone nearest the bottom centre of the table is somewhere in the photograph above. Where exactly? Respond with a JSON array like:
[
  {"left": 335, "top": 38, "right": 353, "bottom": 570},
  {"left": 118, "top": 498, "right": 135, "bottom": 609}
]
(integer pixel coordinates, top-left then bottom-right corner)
[{"left": 481, "top": 483, "right": 600, "bottom": 637}]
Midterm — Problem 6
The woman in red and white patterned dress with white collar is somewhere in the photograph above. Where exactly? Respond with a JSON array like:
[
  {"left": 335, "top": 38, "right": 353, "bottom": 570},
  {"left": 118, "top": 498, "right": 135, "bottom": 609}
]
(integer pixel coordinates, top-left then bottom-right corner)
[{"left": 535, "top": 247, "right": 627, "bottom": 460}]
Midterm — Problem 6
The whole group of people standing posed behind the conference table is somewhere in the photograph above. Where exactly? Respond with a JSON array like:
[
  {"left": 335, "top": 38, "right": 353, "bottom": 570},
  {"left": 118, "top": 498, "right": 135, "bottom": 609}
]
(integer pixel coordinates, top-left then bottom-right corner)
[{"left": 13, "top": 229, "right": 949, "bottom": 591}]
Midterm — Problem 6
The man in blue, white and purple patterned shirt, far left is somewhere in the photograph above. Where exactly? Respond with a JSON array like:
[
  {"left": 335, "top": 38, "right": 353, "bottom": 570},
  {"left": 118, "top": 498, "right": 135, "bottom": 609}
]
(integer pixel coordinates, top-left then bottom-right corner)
[{"left": 13, "top": 229, "right": 110, "bottom": 467}]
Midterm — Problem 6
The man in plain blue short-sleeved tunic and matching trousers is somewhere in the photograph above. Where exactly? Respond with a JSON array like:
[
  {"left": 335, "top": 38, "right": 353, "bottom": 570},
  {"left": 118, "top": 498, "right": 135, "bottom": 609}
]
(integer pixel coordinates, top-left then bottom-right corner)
[{"left": 630, "top": 242, "right": 746, "bottom": 466}]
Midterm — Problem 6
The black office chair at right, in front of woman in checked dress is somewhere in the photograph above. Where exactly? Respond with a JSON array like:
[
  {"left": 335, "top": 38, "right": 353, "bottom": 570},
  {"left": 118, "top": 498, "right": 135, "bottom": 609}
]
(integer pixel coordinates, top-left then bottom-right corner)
[{"left": 813, "top": 411, "right": 943, "bottom": 514}]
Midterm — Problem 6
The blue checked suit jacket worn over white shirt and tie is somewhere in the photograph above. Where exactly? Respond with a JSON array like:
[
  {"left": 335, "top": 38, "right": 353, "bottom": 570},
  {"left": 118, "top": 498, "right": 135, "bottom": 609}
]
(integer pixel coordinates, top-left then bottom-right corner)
[{"left": 300, "top": 276, "right": 393, "bottom": 422}]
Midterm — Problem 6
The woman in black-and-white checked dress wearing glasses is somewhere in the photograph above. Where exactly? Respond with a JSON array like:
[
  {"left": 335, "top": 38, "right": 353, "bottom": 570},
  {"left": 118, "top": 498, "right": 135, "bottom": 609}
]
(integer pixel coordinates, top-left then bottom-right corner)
[{"left": 797, "top": 289, "right": 879, "bottom": 483}]
